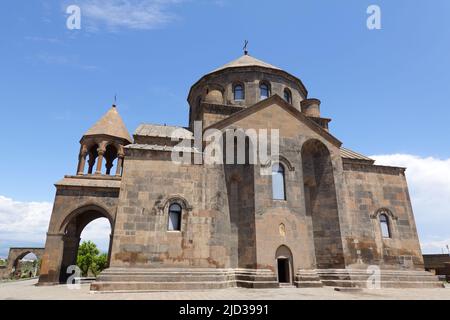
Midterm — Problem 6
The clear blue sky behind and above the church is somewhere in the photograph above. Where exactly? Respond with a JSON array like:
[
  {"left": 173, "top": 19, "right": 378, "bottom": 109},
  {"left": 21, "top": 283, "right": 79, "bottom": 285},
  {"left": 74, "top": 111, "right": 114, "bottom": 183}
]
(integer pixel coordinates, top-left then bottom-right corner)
[{"left": 0, "top": 0, "right": 450, "bottom": 255}]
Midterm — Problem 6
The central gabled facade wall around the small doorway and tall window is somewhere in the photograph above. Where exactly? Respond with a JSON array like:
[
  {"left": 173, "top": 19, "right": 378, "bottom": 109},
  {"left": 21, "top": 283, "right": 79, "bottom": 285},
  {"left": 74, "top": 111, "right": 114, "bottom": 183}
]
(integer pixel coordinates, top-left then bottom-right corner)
[{"left": 216, "top": 105, "right": 342, "bottom": 271}]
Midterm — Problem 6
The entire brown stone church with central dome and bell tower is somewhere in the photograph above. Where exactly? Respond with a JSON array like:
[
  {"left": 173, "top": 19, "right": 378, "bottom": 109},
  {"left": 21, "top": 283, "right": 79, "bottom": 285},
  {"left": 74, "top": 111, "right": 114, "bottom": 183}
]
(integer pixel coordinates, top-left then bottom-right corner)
[{"left": 39, "top": 52, "right": 441, "bottom": 291}]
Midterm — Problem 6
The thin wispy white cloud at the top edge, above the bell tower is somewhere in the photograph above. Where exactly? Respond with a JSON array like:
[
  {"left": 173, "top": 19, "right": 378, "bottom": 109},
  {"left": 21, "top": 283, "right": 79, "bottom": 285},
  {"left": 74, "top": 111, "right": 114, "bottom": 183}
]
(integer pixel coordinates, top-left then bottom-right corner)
[{"left": 75, "top": 0, "right": 185, "bottom": 30}]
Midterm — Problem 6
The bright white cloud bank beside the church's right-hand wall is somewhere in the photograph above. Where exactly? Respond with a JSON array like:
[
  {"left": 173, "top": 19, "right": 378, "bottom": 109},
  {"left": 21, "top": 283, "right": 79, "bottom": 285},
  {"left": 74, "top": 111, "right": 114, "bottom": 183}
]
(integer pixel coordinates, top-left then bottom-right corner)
[{"left": 371, "top": 154, "right": 450, "bottom": 253}]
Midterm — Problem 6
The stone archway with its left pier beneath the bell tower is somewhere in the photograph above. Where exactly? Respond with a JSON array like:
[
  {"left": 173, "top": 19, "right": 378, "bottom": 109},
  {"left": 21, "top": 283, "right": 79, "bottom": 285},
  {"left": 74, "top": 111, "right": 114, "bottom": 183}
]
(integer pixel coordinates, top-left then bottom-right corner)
[{"left": 39, "top": 205, "right": 114, "bottom": 284}]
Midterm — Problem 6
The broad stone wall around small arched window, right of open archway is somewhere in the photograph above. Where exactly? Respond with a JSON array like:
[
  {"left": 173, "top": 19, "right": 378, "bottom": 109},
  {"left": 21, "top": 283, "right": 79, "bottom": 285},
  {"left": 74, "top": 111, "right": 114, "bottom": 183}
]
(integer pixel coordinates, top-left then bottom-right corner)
[{"left": 111, "top": 149, "right": 232, "bottom": 268}]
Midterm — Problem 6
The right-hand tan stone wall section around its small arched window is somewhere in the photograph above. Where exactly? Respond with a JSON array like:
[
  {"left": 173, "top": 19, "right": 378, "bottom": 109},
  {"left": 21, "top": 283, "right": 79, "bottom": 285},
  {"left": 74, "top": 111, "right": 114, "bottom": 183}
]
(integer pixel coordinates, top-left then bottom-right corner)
[{"left": 342, "top": 160, "right": 423, "bottom": 270}]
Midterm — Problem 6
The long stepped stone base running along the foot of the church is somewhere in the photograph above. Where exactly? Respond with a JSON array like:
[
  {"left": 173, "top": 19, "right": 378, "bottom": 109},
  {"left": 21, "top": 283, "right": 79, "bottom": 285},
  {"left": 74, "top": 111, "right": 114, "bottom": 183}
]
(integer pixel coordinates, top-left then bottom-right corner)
[{"left": 91, "top": 268, "right": 443, "bottom": 292}]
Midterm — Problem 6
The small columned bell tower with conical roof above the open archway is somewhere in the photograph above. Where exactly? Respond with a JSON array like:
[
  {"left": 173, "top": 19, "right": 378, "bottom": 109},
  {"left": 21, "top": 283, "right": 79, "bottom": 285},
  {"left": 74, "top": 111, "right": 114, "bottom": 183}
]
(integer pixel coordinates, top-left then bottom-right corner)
[{"left": 77, "top": 105, "right": 132, "bottom": 176}]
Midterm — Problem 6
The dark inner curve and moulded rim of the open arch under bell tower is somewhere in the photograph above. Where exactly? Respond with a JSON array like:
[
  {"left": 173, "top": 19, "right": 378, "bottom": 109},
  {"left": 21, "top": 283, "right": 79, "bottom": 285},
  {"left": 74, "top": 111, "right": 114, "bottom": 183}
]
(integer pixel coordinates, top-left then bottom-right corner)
[{"left": 59, "top": 206, "right": 113, "bottom": 283}]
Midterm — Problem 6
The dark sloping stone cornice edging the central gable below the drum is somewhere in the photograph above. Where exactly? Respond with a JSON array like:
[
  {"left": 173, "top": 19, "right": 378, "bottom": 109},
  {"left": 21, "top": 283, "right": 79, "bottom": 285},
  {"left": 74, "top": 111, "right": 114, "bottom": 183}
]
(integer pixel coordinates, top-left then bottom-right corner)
[{"left": 204, "top": 94, "right": 342, "bottom": 147}]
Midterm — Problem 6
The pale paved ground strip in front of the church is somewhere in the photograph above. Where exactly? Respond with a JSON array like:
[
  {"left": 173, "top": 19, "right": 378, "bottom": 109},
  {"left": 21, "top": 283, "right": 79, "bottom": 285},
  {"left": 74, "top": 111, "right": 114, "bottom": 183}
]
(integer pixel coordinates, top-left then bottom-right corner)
[{"left": 0, "top": 280, "right": 450, "bottom": 300}]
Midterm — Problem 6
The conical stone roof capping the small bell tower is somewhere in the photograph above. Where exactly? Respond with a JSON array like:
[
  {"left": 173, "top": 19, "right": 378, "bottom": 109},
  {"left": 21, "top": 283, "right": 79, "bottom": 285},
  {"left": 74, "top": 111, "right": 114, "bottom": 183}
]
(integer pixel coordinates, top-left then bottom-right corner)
[{"left": 84, "top": 105, "right": 133, "bottom": 143}]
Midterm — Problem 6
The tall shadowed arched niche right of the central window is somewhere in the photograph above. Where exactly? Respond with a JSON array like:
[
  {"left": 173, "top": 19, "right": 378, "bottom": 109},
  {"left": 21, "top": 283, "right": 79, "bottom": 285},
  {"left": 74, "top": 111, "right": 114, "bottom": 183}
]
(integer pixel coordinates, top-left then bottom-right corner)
[{"left": 302, "top": 140, "right": 345, "bottom": 269}]
